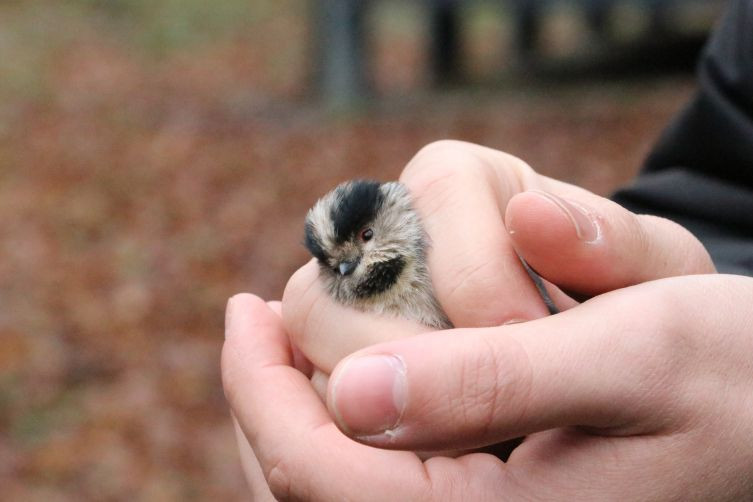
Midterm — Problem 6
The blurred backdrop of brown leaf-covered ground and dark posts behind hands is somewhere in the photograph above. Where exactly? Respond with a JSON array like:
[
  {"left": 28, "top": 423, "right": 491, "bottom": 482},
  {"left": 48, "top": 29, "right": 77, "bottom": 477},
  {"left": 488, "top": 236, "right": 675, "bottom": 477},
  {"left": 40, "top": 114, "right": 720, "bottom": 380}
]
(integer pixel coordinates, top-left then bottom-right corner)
[{"left": 0, "top": 0, "right": 723, "bottom": 502}]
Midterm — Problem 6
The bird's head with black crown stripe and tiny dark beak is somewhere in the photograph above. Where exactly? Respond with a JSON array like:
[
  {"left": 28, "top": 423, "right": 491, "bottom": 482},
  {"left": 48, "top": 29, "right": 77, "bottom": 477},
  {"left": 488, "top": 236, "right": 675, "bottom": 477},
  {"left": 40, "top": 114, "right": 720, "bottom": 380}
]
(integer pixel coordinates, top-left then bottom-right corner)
[{"left": 304, "top": 180, "right": 424, "bottom": 303}]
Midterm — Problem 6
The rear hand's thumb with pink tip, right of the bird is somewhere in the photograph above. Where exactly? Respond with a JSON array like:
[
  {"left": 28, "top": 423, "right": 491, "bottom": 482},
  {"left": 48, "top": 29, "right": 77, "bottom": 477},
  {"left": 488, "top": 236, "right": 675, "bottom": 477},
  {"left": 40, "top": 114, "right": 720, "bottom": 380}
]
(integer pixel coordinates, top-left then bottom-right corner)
[{"left": 505, "top": 185, "right": 714, "bottom": 295}]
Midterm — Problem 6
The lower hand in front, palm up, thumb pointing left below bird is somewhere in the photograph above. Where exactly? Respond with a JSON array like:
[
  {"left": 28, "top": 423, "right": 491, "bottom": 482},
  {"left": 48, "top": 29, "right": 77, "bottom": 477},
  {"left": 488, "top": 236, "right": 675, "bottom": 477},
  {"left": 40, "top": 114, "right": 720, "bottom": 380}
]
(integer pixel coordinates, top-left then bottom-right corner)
[{"left": 223, "top": 275, "right": 753, "bottom": 500}]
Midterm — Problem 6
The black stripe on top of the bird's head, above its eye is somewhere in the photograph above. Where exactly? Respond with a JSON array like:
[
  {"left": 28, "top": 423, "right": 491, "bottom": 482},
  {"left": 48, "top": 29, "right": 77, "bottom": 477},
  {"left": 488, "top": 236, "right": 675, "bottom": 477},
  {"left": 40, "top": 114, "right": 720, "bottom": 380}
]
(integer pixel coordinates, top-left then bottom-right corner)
[{"left": 330, "top": 180, "right": 384, "bottom": 243}]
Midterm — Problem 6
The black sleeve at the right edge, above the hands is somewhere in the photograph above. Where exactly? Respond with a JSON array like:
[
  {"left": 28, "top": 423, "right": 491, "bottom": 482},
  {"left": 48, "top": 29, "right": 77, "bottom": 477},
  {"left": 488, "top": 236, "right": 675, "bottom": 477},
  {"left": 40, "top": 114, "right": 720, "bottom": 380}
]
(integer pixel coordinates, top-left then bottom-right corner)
[{"left": 613, "top": 0, "right": 753, "bottom": 275}]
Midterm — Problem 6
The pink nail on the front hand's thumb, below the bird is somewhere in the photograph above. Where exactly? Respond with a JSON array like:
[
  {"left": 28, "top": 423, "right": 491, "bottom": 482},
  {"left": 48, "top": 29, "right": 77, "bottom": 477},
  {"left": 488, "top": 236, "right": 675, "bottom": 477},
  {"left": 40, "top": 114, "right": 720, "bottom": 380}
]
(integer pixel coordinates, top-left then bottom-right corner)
[{"left": 330, "top": 355, "right": 407, "bottom": 436}]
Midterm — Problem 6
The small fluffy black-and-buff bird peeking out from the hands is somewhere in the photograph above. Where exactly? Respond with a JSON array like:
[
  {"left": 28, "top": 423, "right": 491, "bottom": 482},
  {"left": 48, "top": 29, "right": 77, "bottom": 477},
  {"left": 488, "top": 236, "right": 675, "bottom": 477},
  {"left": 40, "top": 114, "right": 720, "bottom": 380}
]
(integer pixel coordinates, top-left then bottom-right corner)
[{"left": 303, "top": 180, "right": 452, "bottom": 329}]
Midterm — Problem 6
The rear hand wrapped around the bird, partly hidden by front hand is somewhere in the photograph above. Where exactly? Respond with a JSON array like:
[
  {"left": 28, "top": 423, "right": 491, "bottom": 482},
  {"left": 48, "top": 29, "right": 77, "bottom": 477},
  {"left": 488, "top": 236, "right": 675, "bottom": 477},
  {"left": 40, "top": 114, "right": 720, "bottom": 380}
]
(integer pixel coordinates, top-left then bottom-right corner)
[{"left": 282, "top": 141, "right": 714, "bottom": 374}]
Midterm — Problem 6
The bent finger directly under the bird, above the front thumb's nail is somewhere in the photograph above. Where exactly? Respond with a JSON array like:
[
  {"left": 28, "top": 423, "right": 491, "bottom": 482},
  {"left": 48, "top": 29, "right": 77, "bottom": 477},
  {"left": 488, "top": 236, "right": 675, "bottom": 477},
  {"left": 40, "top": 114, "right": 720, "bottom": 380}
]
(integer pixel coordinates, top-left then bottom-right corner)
[{"left": 282, "top": 261, "right": 429, "bottom": 373}]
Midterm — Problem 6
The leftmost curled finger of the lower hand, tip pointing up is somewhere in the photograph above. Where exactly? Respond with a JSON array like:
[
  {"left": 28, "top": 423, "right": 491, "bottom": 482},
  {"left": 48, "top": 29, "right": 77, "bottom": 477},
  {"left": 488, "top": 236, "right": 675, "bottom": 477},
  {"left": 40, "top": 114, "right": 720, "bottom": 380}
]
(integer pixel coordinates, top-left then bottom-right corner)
[{"left": 222, "top": 295, "right": 429, "bottom": 500}]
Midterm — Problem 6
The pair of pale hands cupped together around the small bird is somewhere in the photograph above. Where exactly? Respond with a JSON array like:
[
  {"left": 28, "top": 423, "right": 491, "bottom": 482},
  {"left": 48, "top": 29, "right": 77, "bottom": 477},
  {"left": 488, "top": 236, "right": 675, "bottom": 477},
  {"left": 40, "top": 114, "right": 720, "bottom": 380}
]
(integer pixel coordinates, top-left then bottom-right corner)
[{"left": 222, "top": 142, "right": 753, "bottom": 501}]
